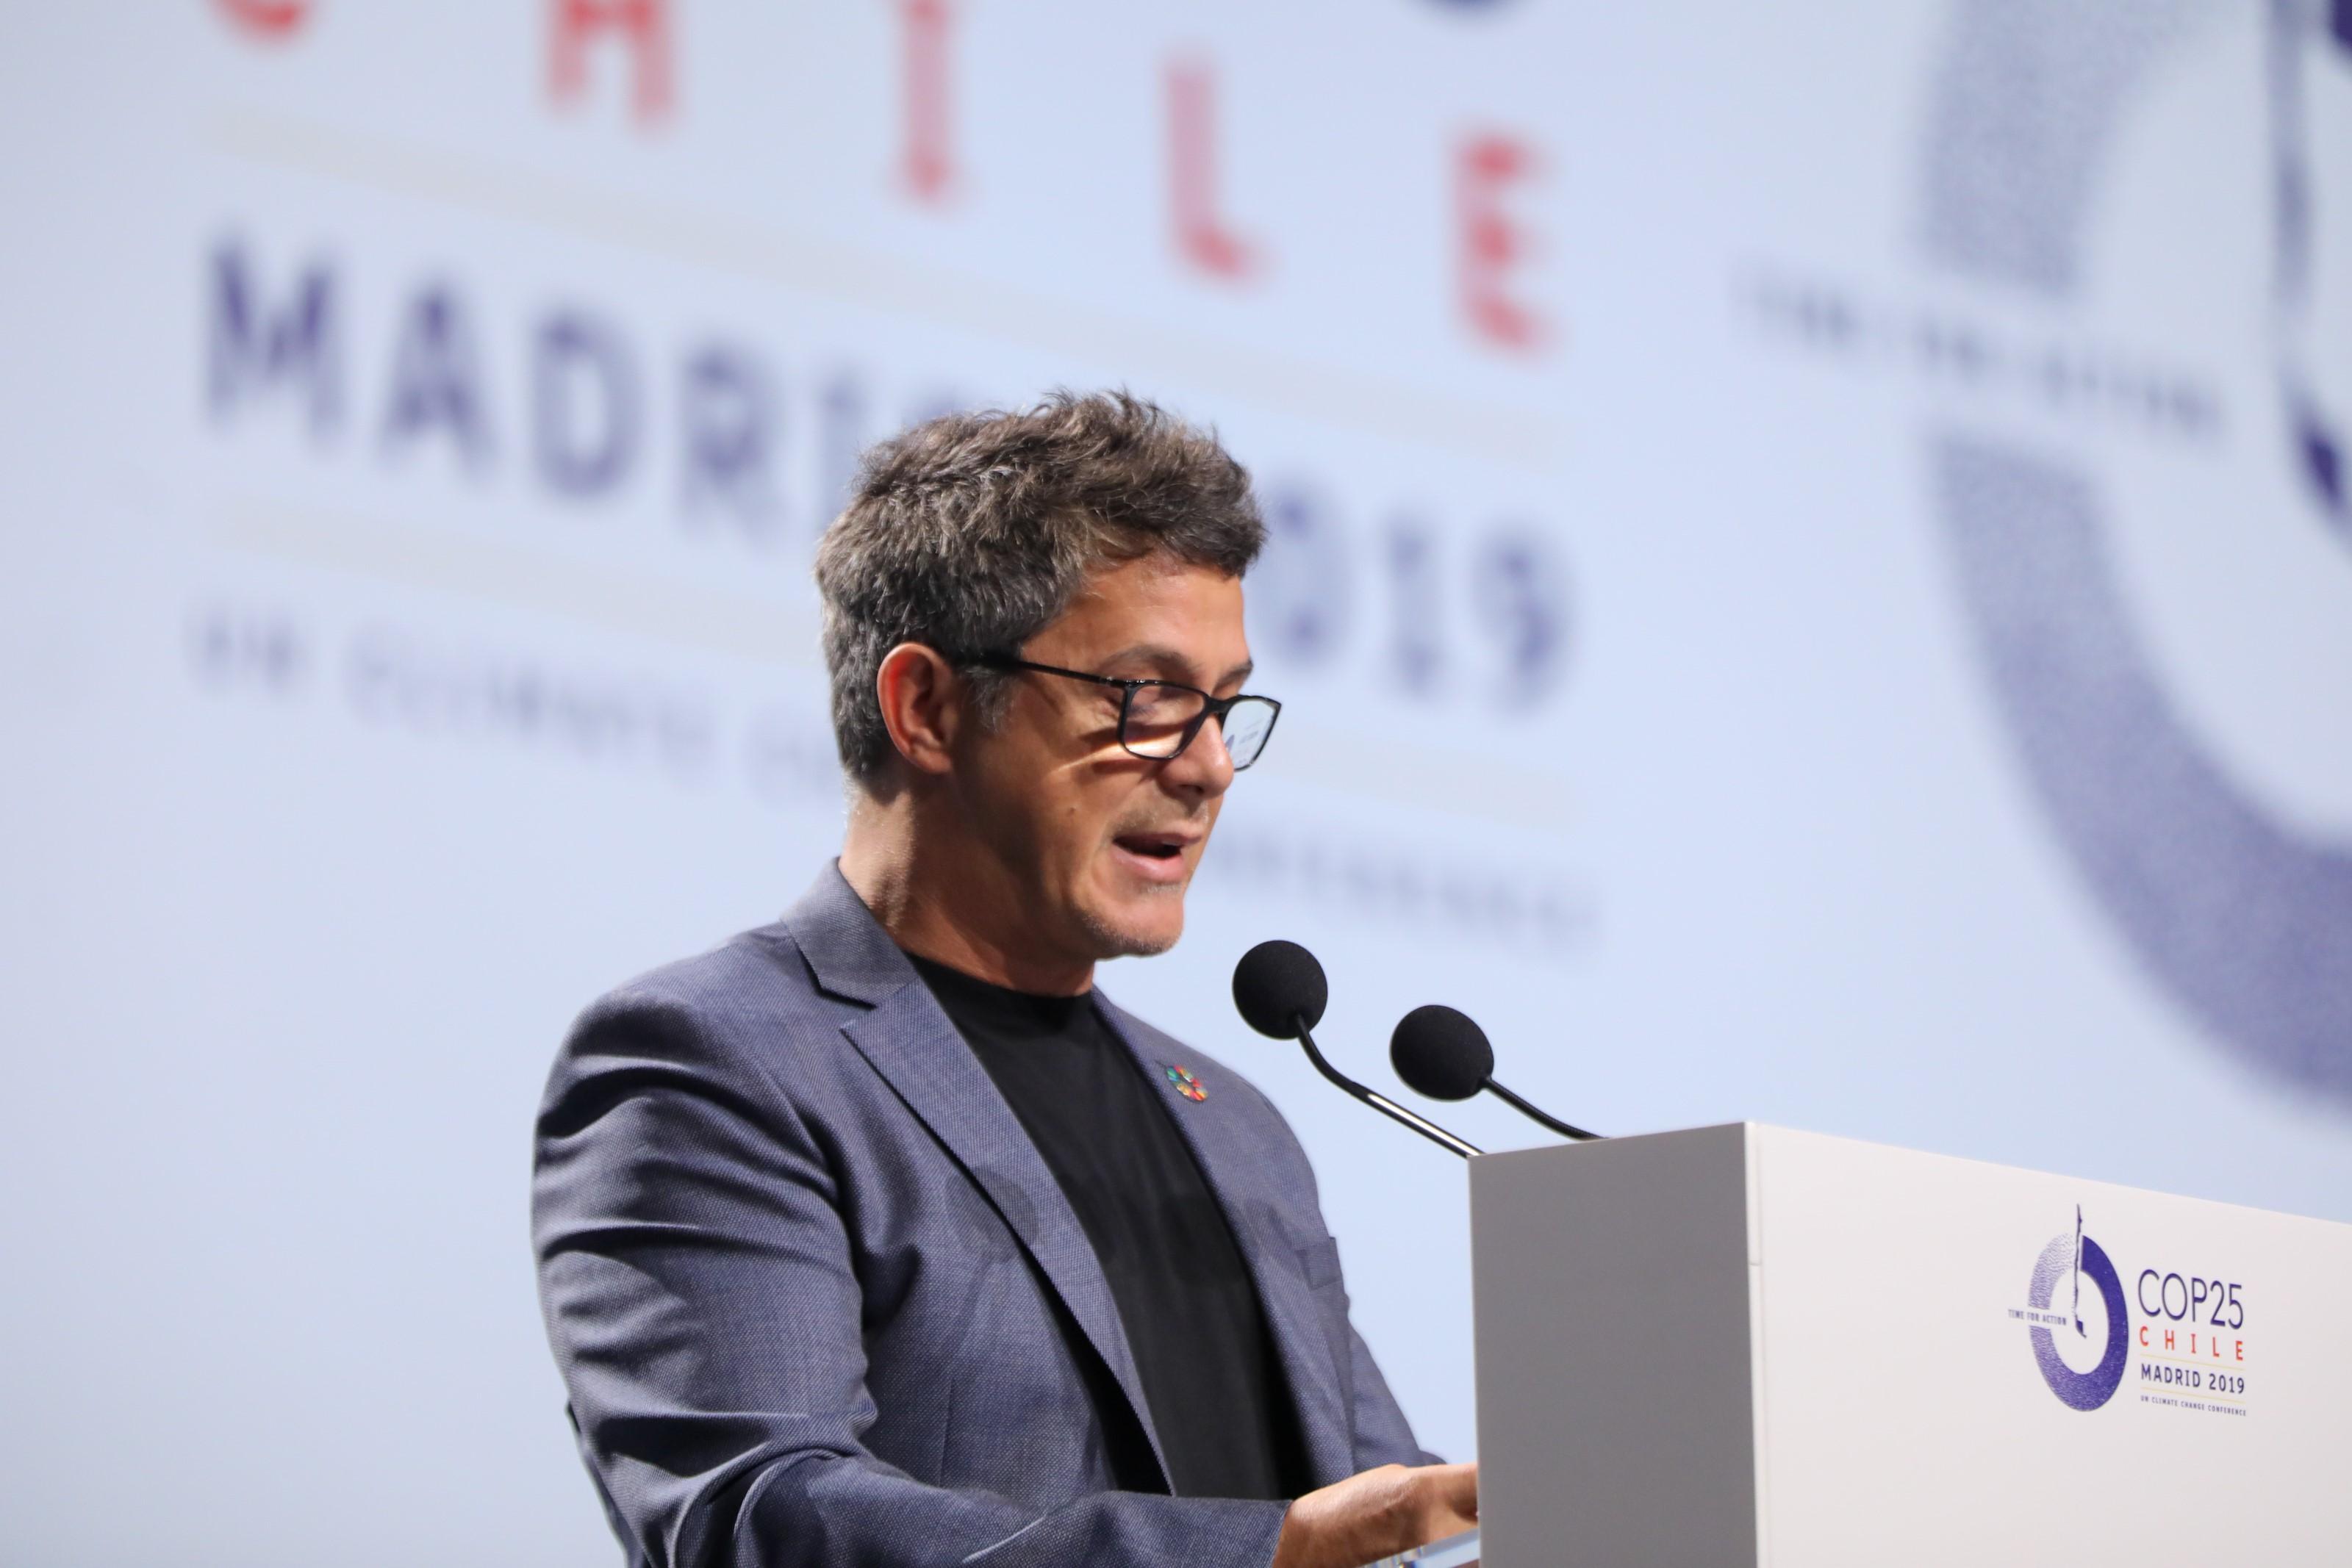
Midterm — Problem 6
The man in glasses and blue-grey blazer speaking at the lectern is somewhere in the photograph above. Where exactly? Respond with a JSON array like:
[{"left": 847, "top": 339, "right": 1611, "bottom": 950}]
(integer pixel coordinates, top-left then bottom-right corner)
[{"left": 534, "top": 395, "right": 1477, "bottom": 1568}]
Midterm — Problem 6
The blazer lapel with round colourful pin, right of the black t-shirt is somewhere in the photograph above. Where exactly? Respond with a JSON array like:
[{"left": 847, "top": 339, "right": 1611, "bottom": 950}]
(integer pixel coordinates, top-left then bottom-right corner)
[{"left": 1096, "top": 992, "right": 1355, "bottom": 1486}]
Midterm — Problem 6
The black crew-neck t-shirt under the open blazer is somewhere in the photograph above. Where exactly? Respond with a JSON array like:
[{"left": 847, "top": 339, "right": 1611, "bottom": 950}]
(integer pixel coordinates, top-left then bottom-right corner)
[{"left": 908, "top": 954, "right": 1310, "bottom": 1500}]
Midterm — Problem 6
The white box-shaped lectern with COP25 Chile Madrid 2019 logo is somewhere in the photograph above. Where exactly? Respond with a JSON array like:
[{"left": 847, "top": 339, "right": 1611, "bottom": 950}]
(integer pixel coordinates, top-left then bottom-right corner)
[{"left": 1470, "top": 1123, "right": 2352, "bottom": 1568}]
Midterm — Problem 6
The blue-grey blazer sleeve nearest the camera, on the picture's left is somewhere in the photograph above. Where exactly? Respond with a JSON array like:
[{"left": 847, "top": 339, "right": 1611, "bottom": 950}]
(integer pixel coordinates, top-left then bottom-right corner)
[{"left": 531, "top": 992, "right": 1284, "bottom": 1568}]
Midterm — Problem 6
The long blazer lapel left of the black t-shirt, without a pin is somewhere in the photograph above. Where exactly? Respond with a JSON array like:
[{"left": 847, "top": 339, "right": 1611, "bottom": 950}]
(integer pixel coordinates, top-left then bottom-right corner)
[{"left": 786, "top": 868, "right": 1169, "bottom": 1481}]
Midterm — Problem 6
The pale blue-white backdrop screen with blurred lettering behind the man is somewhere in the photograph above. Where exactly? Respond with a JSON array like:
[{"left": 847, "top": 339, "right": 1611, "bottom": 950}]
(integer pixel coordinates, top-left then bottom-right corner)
[{"left": 0, "top": 0, "right": 2352, "bottom": 1564}]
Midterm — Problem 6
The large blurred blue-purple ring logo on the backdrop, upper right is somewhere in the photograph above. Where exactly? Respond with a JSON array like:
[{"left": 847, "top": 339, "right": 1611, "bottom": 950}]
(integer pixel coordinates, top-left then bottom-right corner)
[{"left": 1921, "top": 0, "right": 2352, "bottom": 1107}]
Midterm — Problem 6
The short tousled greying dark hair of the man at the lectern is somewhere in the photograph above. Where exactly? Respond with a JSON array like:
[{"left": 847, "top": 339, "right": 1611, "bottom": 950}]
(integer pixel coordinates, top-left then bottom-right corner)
[{"left": 816, "top": 392, "right": 1266, "bottom": 783}]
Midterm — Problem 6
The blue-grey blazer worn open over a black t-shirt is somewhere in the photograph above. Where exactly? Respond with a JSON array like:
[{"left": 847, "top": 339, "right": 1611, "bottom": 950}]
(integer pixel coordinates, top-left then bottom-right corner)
[{"left": 531, "top": 868, "right": 1433, "bottom": 1568}]
